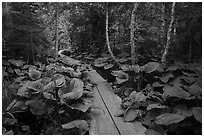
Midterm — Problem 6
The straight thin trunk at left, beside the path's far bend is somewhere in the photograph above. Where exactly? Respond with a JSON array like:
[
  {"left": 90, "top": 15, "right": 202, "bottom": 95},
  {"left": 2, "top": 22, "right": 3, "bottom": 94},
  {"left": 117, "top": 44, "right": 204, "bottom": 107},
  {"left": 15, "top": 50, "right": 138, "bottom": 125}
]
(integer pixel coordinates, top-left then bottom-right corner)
[{"left": 55, "top": 3, "right": 59, "bottom": 60}]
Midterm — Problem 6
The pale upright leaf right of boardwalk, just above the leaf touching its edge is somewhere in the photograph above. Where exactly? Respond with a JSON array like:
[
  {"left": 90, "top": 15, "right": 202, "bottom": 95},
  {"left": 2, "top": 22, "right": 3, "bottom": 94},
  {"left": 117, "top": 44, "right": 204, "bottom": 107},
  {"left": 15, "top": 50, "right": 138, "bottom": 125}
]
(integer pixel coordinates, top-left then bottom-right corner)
[{"left": 130, "top": 91, "right": 146, "bottom": 103}]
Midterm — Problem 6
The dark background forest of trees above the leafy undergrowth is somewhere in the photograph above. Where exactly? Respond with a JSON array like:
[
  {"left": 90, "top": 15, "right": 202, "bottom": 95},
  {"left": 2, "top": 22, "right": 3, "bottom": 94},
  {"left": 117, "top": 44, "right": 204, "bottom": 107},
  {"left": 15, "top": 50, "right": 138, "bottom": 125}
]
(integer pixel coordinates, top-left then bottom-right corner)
[{"left": 2, "top": 2, "right": 202, "bottom": 63}]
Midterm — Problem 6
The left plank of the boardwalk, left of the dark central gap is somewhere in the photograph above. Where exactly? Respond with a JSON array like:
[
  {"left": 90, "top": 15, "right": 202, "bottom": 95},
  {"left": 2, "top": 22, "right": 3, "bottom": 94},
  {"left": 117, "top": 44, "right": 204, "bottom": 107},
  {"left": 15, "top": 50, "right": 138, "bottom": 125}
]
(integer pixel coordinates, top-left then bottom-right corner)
[{"left": 89, "top": 74, "right": 119, "bottom": 135}]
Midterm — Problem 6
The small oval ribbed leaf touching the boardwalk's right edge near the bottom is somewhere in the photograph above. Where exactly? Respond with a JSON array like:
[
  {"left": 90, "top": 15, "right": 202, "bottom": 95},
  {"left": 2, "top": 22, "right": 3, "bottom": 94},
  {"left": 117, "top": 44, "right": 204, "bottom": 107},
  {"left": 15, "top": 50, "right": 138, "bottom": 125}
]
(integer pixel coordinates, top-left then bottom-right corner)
[{"left": 124, "top": 107, "right": 139, "bottom": 122}]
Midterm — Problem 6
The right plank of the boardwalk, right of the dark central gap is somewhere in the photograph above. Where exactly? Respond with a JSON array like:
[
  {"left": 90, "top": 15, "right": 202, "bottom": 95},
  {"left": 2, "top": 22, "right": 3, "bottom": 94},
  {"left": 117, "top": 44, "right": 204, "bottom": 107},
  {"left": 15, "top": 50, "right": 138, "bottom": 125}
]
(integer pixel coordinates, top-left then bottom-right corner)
[{"left": 89, "top": 72, "right": 146, "bottom": 135}]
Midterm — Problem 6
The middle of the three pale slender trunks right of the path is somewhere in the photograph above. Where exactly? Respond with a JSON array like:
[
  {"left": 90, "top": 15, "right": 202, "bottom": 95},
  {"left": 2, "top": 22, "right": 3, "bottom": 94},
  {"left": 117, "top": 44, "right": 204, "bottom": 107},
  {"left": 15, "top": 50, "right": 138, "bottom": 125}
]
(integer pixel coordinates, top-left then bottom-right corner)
[{"left": 130, "top": 2, "right": 139, "bottom": 65}]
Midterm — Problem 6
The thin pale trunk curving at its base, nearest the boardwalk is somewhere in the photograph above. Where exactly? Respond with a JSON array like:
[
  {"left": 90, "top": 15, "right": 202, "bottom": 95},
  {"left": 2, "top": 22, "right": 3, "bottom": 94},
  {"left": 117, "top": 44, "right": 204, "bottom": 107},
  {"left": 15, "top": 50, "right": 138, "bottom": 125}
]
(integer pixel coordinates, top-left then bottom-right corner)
[{"left": 106, "top": 6, "right": 121, "bottom": 67}]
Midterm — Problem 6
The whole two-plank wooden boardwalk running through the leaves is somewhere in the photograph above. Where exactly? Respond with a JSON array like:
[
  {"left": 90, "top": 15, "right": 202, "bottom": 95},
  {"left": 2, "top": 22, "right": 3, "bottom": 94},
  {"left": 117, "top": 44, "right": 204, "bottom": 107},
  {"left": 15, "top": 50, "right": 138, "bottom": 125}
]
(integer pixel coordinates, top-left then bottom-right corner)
[{"left": 88, "top": 70, "right": 146, "bottom": 135}]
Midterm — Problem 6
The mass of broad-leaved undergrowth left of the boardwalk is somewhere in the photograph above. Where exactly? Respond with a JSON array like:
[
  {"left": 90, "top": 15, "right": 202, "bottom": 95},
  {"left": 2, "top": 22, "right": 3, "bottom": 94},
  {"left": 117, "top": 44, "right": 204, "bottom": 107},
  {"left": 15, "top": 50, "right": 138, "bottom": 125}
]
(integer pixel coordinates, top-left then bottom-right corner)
[{"left": 2, "top": 55, "right": 94, "bottom": 135}]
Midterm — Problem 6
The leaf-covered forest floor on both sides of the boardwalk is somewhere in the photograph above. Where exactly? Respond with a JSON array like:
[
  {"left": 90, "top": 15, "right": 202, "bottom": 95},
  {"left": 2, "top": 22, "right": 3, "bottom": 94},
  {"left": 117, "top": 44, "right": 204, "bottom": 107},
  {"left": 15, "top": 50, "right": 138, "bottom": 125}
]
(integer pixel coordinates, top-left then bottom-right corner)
[{"left": 2, "top": 50, "right": 202, "bottom": 135}]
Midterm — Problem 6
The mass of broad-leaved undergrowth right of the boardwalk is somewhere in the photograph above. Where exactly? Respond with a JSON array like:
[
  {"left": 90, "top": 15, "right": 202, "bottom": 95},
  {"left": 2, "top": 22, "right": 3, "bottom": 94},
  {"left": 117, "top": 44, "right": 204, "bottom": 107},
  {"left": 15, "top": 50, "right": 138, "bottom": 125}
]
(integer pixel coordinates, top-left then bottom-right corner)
[{"left": 93, "top": 57, "right": 202, "bottom": 135}]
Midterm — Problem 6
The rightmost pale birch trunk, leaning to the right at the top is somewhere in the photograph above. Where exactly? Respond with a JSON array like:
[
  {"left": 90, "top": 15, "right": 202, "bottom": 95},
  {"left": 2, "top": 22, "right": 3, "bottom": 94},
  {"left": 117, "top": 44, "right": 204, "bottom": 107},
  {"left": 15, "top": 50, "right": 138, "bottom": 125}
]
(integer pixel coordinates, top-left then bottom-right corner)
[{"left": 161, "top": 2, "right": 176, "bottom": 64}]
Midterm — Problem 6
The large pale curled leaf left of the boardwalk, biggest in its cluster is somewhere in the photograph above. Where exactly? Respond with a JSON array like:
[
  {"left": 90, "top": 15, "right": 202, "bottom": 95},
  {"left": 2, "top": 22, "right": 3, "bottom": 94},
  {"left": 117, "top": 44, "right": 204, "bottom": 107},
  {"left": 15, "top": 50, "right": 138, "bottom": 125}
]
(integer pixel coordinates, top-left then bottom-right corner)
[{"left": 61, "top": 78, "right": 84, "bottom": 101}]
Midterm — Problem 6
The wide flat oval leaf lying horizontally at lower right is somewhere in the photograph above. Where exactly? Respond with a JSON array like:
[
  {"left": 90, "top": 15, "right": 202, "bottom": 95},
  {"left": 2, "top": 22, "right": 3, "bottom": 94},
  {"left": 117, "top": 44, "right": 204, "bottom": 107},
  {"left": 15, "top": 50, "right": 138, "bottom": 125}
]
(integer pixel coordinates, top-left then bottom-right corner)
[{"left": 155, "top": 113, "right": 185, "bottom": 125}]
